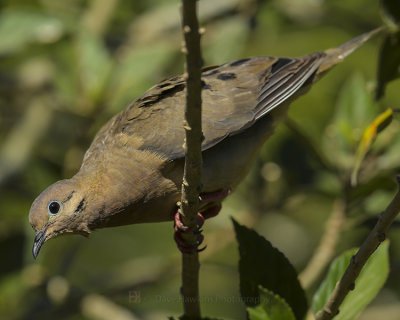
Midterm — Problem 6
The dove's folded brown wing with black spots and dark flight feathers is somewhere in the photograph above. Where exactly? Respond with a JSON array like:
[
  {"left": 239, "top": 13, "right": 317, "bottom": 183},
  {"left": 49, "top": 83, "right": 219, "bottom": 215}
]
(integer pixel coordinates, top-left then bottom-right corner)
[{"left": 85, "top": 53, "right": 324, "bottom": 160}]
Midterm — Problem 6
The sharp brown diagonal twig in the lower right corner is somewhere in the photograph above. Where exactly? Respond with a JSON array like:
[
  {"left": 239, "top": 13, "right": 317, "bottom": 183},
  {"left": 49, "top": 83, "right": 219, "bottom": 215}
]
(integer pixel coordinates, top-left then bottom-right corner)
[{"left": 316, "top": 176, "right": 400, "bottom": 320}]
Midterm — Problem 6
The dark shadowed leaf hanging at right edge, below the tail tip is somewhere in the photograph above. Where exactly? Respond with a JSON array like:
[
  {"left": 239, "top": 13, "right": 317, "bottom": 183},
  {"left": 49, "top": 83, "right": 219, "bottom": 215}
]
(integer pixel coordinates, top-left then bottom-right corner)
[{"left": 375, "top": 31, "right": 400, "bottom": 100}]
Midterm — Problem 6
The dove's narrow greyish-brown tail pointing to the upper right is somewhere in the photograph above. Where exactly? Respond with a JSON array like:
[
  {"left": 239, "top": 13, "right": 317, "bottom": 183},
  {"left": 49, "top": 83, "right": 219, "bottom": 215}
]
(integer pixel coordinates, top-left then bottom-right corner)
[{"left": 317, "top": 26, "right": 385, "bottom": 75}]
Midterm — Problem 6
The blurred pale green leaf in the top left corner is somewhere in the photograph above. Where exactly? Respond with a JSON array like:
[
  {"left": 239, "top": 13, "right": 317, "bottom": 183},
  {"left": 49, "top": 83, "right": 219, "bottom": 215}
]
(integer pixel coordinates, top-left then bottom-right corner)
[{"left": 0, "top": 9, "right": 64, "bottom": 54}]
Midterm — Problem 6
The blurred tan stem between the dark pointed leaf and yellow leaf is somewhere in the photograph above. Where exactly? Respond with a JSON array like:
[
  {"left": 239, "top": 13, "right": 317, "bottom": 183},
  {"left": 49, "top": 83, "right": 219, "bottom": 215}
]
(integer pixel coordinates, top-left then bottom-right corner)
[{"left": 299, "top": 198, "right": 346, "bottom": 289}]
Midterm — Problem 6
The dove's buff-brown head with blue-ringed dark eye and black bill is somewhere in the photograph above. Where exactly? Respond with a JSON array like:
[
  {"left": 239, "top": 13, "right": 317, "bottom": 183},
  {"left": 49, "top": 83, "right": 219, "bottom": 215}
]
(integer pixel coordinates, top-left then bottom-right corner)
[{"left": 29, "top": 180, "right": 90, "bottom": 259}]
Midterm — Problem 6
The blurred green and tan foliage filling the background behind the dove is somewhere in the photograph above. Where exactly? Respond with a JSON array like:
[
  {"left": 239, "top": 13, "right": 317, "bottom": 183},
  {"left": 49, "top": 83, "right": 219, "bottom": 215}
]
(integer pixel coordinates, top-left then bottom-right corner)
[{"left": 0, "top": 0, "right": 400, "bottom": 320}]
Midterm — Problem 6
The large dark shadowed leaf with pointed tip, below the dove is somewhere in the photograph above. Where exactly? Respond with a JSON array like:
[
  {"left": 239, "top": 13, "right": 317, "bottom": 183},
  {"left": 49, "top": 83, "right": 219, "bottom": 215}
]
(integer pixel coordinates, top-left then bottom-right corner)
[{"left": 232, "top": 219, "right": 307, "bottom": 319}]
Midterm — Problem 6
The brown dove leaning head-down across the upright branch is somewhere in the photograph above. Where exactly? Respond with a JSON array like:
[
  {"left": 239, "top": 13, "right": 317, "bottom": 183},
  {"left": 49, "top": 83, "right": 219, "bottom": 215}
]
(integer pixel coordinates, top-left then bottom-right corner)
[{"left": 29, "top": 28, "right": 382, "bottom": 259}]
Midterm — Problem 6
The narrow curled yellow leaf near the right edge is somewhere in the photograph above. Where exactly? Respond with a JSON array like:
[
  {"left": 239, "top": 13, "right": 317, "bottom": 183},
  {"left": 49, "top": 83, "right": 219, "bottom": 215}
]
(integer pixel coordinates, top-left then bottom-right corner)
[{"left": 351, "top": 108, "right": 393, "bottom": 186}]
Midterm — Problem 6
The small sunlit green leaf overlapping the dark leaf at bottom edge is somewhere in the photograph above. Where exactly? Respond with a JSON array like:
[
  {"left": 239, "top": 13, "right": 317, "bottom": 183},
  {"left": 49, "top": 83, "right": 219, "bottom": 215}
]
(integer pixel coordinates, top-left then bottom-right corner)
[{"left": 247, "top": 286, "right": 296, "bottom": 320}]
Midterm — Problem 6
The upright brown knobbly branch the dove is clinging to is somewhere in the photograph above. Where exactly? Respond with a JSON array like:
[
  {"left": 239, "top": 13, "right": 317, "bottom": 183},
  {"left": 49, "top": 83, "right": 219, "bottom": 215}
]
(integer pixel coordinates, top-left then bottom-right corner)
[{"left": 180, "top": 0, "right": 203, "bottom": 318}]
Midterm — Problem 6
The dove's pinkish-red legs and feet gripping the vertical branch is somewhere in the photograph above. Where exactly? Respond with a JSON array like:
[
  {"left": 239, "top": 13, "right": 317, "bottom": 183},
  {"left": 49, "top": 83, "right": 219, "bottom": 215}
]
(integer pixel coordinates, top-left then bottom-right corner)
[{"left": 174, "top": 189, "right": 231, "bottom": 253}]
